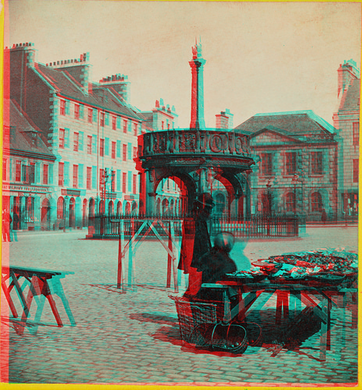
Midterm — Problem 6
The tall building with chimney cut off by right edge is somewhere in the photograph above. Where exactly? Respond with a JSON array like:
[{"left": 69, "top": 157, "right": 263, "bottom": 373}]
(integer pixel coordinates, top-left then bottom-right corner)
[{"left": 333, "top": 60, "right": 361, "bottom": 217}]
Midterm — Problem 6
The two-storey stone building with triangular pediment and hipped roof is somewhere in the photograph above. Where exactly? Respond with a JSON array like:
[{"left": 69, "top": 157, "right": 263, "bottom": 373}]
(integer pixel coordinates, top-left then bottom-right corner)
[{"left": 235, "top": 111, "right": 338, "bottom": 220}]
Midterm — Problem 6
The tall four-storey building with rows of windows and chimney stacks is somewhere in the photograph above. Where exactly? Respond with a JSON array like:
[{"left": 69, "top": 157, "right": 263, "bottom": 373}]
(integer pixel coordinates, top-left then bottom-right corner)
[{"left": 5, "top": 43, "right": 142, "bottom": 227}]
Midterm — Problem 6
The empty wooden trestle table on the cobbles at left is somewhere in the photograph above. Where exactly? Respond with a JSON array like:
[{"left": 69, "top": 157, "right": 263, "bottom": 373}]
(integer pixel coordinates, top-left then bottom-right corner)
[{"left": 1, "top": 266, "right": 76, "bottom": 335}]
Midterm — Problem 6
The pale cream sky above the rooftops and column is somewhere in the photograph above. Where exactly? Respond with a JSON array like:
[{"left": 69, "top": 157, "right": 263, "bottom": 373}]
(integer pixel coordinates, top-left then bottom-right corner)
[{"left": 5, "top": 0, "right": 361, "bottom": 127}]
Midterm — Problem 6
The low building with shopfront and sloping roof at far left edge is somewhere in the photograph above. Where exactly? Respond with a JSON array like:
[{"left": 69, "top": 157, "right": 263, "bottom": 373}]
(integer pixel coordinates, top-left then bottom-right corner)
[{"left": 2, "top": 99, "right": 56, "bottom": 230}]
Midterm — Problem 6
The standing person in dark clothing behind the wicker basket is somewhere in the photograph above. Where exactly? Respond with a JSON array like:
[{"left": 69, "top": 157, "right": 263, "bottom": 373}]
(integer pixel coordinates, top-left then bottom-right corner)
[{"left": 178, "top": 192, "right": 215, "bottom": 296}]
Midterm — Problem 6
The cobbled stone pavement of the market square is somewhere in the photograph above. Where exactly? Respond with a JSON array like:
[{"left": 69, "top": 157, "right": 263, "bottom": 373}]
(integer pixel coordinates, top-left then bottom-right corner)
[{"left": 2, "top": 227, "right": 358, "bottom": 386}]
